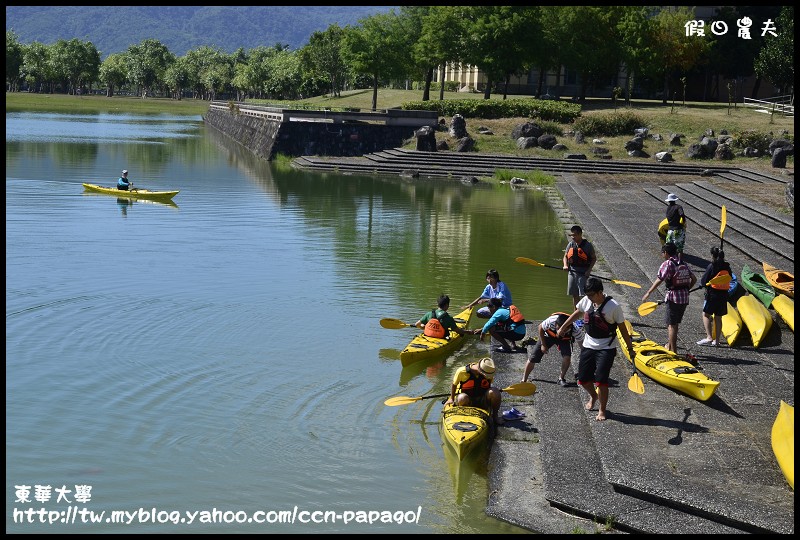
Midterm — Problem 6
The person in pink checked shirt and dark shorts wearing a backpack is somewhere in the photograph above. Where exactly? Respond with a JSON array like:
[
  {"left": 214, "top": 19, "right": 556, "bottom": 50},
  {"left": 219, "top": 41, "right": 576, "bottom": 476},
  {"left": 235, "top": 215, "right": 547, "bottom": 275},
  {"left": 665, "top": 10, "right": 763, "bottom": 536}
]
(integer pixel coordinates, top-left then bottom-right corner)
[{"left": 642, "top": 242, "right": 697, "bottom": 353}]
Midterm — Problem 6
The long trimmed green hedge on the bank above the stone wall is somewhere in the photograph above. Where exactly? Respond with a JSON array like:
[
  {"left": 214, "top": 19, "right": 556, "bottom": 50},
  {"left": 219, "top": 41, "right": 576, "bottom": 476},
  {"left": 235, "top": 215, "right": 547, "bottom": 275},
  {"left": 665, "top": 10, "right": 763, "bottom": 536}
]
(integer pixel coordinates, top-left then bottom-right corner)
[{"left": 401, "top": 98, "right": 581, "bottom": 124}]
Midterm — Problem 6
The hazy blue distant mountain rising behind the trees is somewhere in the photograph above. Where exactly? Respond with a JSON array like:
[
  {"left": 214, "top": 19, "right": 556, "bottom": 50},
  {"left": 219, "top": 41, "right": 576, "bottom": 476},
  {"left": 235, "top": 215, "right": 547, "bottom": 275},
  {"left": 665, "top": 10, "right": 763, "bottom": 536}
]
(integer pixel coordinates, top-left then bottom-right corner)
[{"left": 6, "top": 6, "right": 400, "bottom": 59}]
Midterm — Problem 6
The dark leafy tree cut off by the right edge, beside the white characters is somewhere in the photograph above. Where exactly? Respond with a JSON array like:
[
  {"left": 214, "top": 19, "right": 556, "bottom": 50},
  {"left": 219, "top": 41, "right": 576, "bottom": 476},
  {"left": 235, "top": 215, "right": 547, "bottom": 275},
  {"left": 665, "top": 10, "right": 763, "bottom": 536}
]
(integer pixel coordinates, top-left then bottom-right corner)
[{"left": 755, "top": 6, "right": 794, "bottom": 94}]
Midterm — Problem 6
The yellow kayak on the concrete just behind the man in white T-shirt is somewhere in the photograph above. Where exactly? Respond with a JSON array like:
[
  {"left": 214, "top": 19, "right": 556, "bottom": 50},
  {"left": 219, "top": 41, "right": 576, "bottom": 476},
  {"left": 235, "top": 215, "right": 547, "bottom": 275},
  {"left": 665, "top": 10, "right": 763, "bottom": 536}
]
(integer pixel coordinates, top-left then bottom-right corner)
[{"left": 617, "top": 321, "right": 719, "bottom": 401}]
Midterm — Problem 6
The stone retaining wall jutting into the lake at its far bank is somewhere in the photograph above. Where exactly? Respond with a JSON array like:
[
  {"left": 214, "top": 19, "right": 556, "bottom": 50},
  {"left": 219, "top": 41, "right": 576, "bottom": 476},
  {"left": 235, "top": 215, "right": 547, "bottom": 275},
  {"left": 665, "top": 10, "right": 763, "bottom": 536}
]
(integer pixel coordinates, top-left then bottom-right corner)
[{"left": 203, "top": 108, "right": 432, "bottom": 160}]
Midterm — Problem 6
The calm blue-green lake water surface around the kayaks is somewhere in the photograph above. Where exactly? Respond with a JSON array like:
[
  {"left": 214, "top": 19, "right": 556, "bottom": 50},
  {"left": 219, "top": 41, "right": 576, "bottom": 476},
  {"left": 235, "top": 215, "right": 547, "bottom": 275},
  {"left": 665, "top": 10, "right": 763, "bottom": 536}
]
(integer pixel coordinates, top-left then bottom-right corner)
[{"left": 6, "top": 108, "right": 570, "bottom": 533}]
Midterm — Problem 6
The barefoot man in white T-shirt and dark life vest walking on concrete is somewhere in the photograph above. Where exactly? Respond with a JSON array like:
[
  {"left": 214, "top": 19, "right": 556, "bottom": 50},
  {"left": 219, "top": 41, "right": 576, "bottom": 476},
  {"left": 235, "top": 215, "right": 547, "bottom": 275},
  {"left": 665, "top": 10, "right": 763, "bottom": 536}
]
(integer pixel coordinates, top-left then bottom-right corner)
[{"left": 556, "top": 277, "right": 635, "bottom": 422}]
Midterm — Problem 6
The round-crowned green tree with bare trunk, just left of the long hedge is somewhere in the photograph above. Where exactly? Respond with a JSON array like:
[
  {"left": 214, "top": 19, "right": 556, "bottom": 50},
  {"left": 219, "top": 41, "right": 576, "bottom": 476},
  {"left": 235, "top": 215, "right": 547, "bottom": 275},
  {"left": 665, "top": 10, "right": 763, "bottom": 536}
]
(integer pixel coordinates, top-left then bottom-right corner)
[{"left": 342, "top": 11, "right": 411, "bottom": 110}]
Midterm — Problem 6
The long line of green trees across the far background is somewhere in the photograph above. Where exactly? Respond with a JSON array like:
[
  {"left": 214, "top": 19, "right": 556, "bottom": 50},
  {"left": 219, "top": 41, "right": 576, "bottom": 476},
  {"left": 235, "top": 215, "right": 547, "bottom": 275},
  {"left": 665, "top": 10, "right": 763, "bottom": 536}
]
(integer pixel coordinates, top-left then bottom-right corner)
[{"left": 6, "top": 6, "right": 794, "bottom": 109}]
